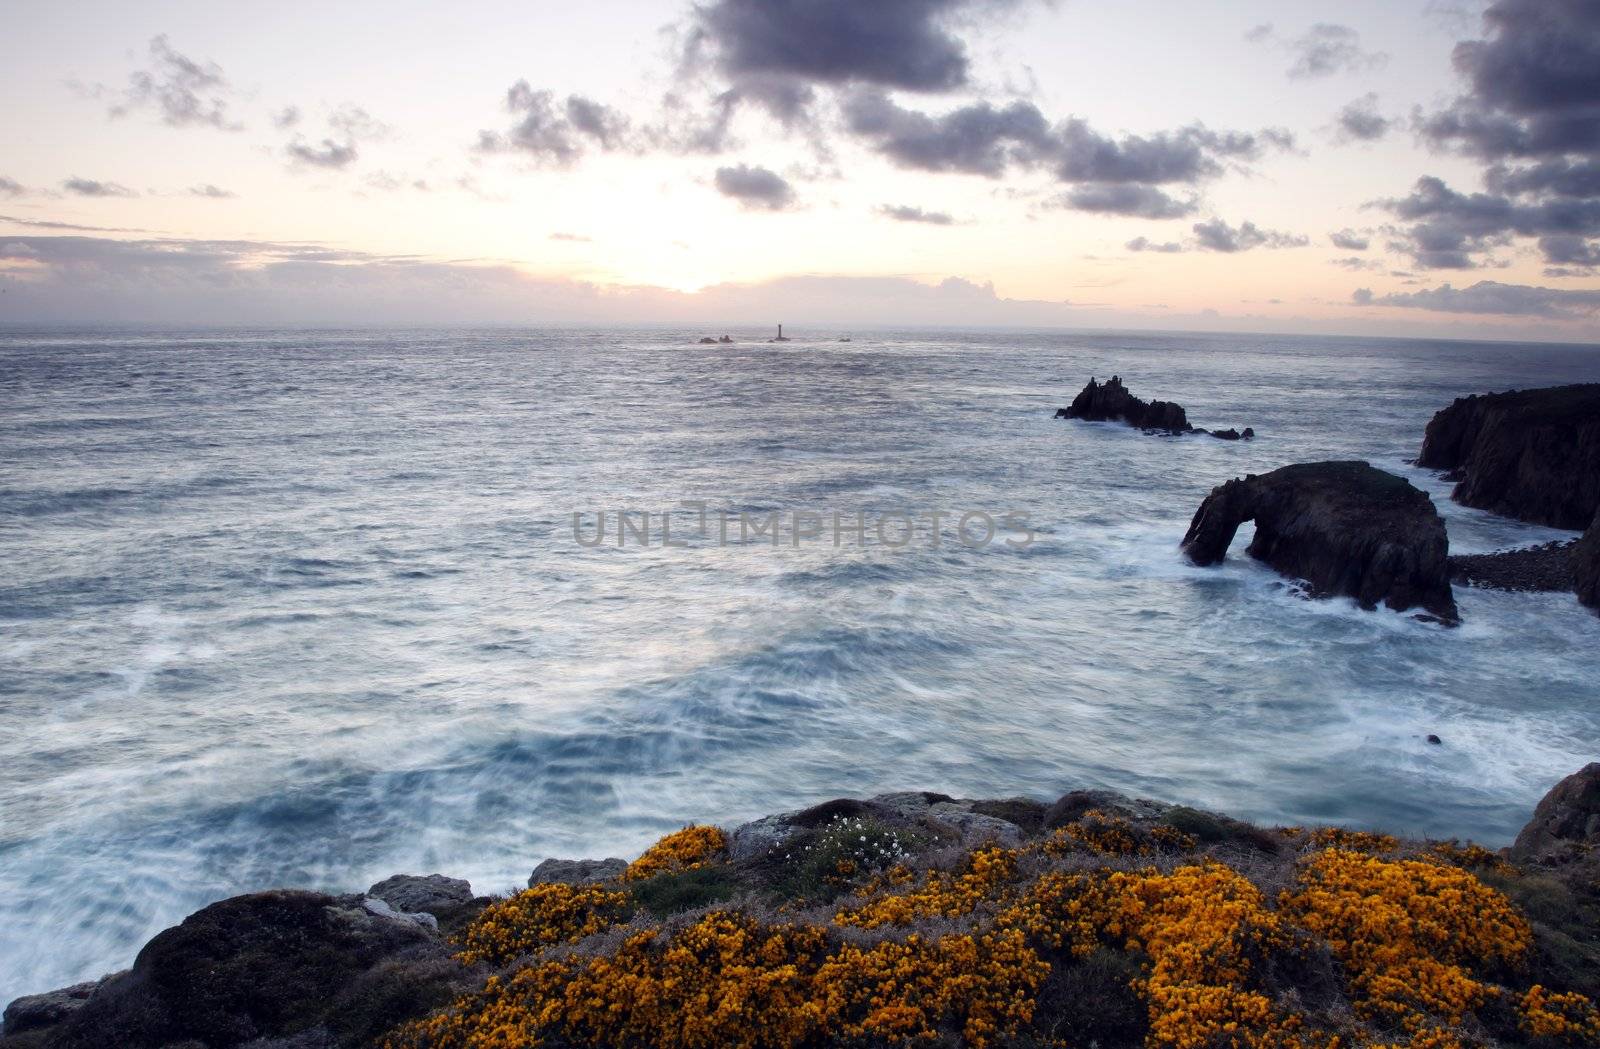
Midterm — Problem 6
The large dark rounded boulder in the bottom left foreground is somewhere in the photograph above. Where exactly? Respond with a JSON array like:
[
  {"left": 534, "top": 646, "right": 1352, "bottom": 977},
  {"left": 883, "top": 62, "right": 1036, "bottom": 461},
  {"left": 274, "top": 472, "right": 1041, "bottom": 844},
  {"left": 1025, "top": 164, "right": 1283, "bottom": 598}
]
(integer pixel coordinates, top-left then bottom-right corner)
[{"left": 39, "top": 891, "right": 451, "bottom": 1049}]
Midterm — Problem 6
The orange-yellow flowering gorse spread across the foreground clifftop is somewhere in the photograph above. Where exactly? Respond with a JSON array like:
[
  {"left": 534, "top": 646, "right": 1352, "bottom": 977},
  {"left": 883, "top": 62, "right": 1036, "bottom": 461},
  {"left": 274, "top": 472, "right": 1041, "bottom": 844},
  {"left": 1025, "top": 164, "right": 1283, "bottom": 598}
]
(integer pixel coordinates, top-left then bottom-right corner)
[{"left": 389, "top": 814, "right": 1600, "bottom": 1049}]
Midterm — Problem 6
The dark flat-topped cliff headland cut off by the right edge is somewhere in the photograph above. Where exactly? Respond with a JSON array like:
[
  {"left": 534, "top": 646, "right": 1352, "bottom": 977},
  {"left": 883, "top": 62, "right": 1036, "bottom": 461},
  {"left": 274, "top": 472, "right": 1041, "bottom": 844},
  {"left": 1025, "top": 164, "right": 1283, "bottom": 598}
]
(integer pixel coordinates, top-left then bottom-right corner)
[{"left": 1418, "top": 384, "right": 1600, "bottom": 529}]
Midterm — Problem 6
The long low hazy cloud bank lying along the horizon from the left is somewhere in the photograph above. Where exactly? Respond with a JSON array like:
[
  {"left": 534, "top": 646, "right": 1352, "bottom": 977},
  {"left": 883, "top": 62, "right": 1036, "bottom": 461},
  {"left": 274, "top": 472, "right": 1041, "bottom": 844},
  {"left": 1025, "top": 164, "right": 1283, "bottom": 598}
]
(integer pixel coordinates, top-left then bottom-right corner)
[{"left": 0, "top": 237, "right": 1083, "bottom": 326}]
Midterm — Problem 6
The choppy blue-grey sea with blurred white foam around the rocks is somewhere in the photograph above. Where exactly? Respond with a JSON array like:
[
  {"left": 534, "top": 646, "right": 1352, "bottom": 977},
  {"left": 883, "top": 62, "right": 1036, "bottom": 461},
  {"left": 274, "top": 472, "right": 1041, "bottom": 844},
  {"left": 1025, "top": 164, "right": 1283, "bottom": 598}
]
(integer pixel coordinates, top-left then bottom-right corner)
[{"left": 0, "top": 326, "right": 1600, "bottom": 1001}]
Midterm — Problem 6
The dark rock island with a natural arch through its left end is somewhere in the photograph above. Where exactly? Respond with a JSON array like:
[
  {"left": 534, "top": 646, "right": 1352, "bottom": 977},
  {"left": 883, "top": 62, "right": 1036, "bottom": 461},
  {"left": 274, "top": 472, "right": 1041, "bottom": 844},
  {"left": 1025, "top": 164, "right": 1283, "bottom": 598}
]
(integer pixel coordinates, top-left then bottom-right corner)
[{"left": 1182, "top": 462, "right": 1458, "bottom": 622}]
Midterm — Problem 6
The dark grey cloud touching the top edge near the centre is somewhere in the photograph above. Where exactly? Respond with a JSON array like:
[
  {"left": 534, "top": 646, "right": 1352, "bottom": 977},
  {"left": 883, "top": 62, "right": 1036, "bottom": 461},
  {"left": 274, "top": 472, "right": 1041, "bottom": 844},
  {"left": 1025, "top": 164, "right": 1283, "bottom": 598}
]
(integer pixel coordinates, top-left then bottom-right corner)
[{"left": 690, "top": 0, "right": 1014, "bottom": 91}]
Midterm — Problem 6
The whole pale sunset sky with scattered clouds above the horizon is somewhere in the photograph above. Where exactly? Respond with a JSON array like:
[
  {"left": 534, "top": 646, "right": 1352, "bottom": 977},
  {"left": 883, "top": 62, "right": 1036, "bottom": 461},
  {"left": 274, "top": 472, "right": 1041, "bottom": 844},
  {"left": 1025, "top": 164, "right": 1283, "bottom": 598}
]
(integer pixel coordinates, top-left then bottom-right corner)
[{"left": 0, "top": 0, "right": 1600, "bottom": 342}]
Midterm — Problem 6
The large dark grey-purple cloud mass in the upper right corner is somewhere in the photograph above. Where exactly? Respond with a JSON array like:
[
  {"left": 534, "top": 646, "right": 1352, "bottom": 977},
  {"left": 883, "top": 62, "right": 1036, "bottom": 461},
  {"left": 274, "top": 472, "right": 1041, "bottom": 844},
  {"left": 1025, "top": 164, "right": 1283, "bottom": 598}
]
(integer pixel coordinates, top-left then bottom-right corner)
[{"left": 1381, "top": 0, "right": 1600, "bottom": 269}]
